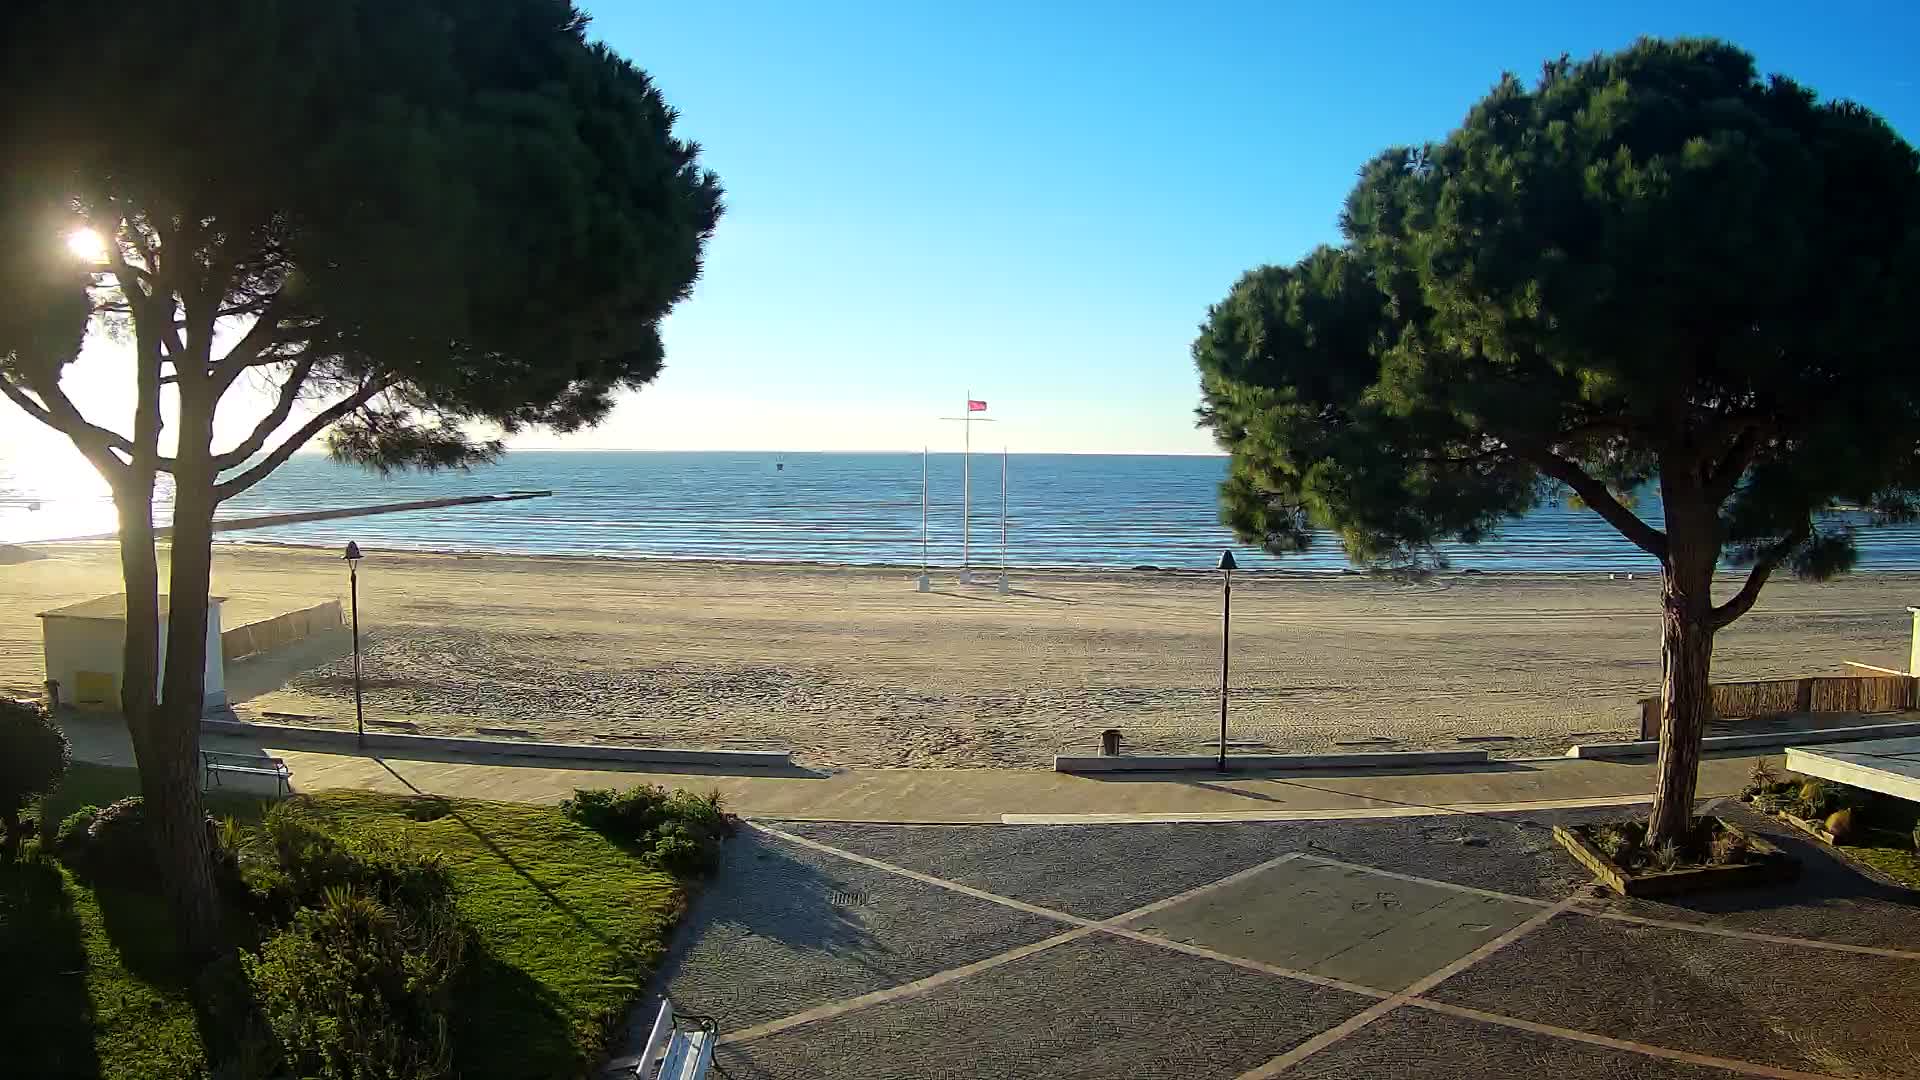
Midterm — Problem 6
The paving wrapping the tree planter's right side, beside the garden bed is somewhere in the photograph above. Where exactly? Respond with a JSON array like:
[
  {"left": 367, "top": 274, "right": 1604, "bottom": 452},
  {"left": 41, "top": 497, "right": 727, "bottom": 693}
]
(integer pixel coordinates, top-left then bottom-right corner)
[{"left": 1607, "top": 803, "right": 1920, "bottom": 951}]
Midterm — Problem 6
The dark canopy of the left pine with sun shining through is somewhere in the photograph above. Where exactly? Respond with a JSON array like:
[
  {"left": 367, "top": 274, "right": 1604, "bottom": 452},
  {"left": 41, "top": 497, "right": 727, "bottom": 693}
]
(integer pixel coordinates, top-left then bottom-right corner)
[{"left": 0, "top": 0, "right": 720, "bottom": 478}]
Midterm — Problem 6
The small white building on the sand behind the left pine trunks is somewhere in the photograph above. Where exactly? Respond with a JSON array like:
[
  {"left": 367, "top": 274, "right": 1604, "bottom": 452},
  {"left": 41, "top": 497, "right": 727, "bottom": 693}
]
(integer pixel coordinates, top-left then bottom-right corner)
[{"left": 40, "top": 592, "right": 227, "bottom": 713}]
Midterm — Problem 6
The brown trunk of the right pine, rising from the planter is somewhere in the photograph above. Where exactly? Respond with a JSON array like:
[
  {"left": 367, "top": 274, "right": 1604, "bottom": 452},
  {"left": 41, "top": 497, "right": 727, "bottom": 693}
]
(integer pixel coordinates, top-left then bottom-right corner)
[{"left": 1647, "top": 528, "right": 1718, "bottom": 844}]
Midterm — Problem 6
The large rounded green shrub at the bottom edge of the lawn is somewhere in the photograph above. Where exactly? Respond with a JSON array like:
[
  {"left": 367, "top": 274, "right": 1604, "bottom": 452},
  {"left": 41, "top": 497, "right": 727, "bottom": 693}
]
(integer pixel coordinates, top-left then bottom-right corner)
[{"left": 242, "top": 886, "right": 467, "bottom": 1080}]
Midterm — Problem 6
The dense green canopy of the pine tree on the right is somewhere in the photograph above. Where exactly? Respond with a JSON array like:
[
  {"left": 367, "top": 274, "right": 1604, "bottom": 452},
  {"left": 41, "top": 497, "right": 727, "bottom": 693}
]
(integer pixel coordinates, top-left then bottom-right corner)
[{"left": 1192, "top": 40, "right": 1920, "bottom": 588}]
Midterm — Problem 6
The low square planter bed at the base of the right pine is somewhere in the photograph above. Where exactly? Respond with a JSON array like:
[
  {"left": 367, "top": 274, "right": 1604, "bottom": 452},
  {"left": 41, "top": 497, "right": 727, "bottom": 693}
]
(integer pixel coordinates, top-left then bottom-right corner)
[{"left": 1553, "top": 817, "right": 1799, "bottom": 897}]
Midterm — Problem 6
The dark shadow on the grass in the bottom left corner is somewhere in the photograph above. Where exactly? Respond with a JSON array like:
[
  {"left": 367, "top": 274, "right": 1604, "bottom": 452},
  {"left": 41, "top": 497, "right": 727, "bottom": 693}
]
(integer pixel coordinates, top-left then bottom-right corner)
[{"left": 0, "top": 859, "right": 100, "bottom": 1080}]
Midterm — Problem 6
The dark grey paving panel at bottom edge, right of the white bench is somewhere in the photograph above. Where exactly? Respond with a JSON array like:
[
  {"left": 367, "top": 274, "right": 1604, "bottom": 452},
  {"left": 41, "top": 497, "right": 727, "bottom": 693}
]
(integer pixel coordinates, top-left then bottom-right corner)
[{"left": 718, "top": 934, "right": 1373, "bottom": 1080}]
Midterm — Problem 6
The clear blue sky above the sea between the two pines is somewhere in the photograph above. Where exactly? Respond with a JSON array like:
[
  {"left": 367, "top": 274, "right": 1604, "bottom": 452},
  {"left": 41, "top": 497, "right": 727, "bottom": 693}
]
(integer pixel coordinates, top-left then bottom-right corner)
[{"left": 568, "top": 0, "right": 1920, "bottom": 452}]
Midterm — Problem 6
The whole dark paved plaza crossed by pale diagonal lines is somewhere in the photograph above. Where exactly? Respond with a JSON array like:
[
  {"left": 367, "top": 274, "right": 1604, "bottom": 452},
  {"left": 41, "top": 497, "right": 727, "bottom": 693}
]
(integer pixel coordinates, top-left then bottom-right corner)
[{"left": 641, "top": 803, "right": 1920, "bottom": 1080}]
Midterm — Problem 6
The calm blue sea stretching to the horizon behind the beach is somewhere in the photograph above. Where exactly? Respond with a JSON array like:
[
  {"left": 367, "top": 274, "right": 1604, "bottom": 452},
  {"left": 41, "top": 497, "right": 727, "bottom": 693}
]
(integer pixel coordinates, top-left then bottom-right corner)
[{"left": 0, "top": 450, "right": 1920, "bottom": 571}]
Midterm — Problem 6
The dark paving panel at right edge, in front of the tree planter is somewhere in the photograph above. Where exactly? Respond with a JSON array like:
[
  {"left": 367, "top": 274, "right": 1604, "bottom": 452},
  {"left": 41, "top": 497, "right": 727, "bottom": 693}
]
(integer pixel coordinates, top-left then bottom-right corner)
[{"left": 1428, "top": 915, "right": 1920, "bottom": 1076}]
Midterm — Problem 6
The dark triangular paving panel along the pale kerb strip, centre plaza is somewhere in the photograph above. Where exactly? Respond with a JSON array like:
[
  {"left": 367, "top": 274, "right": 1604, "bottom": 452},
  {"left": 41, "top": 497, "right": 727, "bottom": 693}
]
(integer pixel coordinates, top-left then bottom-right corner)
[{"left": 770, "top": 822, "right": 1300, "bottom": 919}]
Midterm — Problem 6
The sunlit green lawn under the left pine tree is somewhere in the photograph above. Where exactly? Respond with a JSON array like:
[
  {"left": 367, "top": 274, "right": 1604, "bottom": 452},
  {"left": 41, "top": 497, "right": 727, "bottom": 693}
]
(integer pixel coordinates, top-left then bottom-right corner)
[{"left": 0, "top": 765, "right": 684, "bottom": 1080}]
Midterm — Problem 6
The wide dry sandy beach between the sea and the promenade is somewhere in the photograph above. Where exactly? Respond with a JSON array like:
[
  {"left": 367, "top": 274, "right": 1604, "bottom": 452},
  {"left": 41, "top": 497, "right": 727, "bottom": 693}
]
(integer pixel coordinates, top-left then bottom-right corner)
[{"left": 0, "top": 544, "right": 1920, "bottom": 767}]
